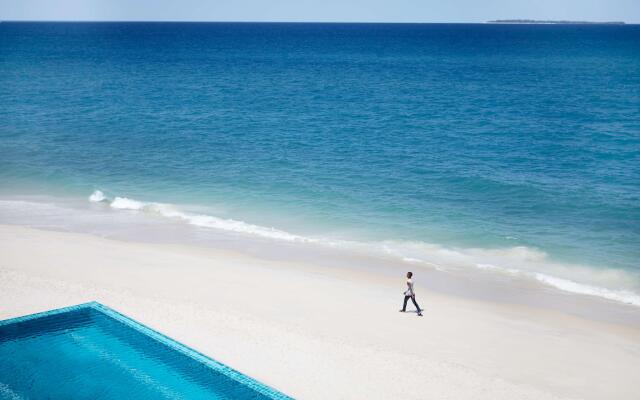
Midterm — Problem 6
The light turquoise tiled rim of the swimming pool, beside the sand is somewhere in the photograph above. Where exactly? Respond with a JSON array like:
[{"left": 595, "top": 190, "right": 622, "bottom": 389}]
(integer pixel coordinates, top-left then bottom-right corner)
[{"left": 0, "top": 301, "right": 293, "bottom": 400}]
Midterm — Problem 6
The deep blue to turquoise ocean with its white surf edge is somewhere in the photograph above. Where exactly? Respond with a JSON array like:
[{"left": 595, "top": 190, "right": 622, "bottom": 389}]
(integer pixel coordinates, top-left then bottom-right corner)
[{"left": 0, "top": 22, "right": 640, "bottom": 306}]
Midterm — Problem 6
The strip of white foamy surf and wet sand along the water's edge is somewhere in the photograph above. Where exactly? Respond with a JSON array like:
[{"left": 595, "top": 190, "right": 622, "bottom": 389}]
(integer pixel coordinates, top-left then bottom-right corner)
[{"left": 0, "top": 195, "right": 640, "bottom": 327}]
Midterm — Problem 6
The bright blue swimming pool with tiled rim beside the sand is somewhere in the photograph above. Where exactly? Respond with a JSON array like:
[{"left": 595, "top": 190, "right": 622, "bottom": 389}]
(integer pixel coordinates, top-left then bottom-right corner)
[{"left": 0, "top": 302, "right": 290, "bottom": 399}]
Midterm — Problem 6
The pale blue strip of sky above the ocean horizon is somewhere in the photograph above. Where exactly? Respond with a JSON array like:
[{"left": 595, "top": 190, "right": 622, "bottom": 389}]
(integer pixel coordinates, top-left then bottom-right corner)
[{"left": 0, "top": 0, "right": 640, "bottom": 23}]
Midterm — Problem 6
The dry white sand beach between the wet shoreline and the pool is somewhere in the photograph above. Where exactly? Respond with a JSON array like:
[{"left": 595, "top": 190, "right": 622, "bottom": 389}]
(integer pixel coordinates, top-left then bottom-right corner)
[{"left": 0, "top": 225, "right": 640, "bottom": 399}]
